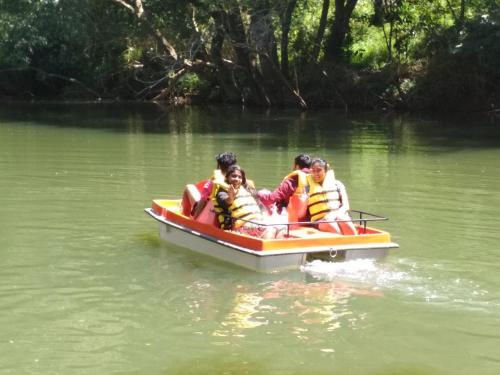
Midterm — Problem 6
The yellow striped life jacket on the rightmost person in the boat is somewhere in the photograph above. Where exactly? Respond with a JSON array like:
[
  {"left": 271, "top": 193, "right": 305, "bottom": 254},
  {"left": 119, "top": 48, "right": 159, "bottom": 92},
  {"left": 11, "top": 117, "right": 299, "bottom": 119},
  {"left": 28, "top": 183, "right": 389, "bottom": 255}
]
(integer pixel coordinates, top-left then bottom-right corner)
[{"left": 307, "top": 169, "right": 342, "bottom": 221}]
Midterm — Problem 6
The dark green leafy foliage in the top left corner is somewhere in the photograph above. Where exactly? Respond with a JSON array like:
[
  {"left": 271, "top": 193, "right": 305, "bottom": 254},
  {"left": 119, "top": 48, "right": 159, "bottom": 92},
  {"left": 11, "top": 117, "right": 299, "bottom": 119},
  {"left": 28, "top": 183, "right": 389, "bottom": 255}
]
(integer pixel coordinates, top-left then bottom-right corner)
[{"left": 0, "top": 0, "right": 133, "bottom": 95}]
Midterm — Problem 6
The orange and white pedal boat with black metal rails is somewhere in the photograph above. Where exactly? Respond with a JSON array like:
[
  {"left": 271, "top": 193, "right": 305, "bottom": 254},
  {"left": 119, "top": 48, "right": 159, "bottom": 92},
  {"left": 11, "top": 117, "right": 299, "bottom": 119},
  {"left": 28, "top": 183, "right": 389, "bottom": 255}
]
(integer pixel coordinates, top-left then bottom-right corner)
[{"left": 145, "top": 200, "right": 399, "bottom": 272}]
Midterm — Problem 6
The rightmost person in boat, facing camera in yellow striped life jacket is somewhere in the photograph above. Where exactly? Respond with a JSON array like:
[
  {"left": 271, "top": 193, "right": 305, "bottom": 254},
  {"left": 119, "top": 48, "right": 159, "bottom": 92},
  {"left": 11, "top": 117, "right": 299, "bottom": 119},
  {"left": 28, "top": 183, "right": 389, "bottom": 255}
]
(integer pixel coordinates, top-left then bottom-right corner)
[{"left": 307, "top": 158, "right": 358, "bottom": 235}]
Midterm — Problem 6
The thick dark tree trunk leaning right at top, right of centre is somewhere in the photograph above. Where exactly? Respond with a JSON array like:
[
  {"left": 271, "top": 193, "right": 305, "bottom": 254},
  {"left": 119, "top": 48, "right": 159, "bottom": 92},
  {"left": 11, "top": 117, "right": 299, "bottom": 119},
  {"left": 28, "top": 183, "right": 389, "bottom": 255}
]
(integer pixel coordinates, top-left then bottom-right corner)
[{"left": 325, "top": 0, "right": 358, "bottom": 62}]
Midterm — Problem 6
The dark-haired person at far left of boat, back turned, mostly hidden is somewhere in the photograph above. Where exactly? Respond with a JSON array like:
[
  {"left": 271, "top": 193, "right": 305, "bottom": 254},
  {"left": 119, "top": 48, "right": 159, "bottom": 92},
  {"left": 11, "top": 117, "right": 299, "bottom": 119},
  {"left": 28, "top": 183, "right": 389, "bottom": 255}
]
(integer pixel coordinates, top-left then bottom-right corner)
[{"left": 181, "top": 151, "right": 237, "bottom": 221}]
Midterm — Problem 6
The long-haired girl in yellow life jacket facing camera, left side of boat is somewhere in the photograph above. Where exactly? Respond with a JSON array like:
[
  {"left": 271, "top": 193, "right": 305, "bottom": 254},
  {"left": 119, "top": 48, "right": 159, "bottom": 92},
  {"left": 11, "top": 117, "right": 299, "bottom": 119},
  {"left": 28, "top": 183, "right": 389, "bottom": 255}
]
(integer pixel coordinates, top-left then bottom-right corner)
[{"left": 214, "top": 164, "right": 286, "bottom": 239}]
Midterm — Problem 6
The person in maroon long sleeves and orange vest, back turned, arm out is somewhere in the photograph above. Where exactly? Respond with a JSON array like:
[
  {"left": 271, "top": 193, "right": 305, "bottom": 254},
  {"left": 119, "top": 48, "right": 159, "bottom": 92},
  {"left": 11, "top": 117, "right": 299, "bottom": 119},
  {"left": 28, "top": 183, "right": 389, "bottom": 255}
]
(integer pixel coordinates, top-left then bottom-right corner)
[{"left": 258, "top": 154, "right": 311, "bottom": 226}]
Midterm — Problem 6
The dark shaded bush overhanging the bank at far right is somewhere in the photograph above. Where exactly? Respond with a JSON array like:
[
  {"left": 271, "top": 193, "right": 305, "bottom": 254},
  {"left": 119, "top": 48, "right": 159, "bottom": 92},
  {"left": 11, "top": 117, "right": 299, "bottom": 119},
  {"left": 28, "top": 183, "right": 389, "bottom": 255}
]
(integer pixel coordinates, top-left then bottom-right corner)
[{"left": 410, "top": 8, "right": 500, "bottom": 109}]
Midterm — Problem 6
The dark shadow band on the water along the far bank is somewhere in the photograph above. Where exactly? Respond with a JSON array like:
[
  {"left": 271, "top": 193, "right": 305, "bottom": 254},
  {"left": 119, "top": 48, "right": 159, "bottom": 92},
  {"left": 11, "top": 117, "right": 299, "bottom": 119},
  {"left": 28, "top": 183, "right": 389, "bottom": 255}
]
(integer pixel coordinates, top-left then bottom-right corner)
[{"left": 0, "top": 102, "right": 500, "bottom": 153}]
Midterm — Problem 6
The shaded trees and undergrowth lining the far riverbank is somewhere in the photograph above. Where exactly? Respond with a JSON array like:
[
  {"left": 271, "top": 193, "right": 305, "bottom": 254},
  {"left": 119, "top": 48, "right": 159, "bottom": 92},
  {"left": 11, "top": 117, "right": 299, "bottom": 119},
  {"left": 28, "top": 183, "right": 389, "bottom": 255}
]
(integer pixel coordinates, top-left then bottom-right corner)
[{"left": 0, "top": 0, "right": 500, "bottom": 113}]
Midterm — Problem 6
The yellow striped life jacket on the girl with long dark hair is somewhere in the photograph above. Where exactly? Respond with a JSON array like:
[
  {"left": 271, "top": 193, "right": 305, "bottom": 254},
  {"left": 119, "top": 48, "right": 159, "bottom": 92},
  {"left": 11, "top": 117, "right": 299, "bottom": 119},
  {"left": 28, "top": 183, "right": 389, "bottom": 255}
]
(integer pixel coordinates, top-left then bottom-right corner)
[{"left": 215, "top": 186, "right": 261, "bottom": 229}]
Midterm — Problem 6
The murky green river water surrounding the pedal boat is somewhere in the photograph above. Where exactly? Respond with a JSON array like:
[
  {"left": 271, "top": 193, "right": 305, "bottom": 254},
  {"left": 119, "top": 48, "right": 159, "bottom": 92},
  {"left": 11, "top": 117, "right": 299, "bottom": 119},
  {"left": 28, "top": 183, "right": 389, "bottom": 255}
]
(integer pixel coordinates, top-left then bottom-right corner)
[{"left": 0, "top": 104, "right": 500, "bottom": 375}]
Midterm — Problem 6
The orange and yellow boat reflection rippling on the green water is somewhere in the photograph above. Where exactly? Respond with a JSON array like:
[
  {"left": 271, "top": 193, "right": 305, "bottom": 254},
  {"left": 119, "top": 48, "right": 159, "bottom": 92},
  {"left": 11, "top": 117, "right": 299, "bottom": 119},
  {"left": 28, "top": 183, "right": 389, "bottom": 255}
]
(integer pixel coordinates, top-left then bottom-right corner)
[{"left": 213, "top": 280, "right": 383, "bottom": 340}]
